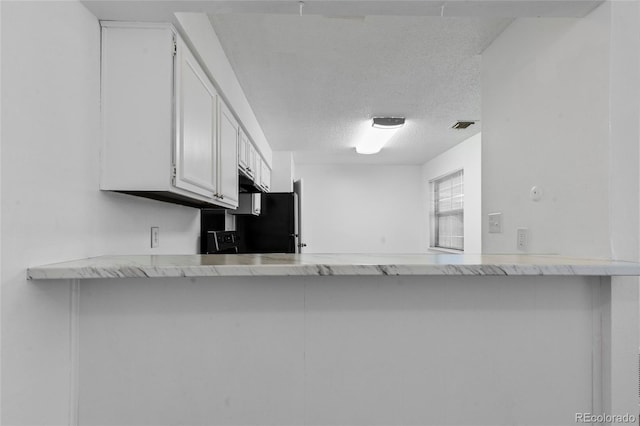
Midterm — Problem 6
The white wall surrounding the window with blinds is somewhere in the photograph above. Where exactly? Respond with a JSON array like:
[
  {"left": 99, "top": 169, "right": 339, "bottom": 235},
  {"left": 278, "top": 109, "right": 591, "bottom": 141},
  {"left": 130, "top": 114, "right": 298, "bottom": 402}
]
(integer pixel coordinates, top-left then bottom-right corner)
[{"left": 422, "top": 133, "right": 482, "bottom": 253}]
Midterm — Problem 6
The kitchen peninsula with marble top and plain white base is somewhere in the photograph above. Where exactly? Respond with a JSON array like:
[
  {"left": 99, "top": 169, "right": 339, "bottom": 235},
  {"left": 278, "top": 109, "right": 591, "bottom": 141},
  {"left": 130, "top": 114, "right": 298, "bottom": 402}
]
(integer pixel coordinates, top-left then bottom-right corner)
[{"left": 28, "top": 254, "right": 640, "bottom": 425}]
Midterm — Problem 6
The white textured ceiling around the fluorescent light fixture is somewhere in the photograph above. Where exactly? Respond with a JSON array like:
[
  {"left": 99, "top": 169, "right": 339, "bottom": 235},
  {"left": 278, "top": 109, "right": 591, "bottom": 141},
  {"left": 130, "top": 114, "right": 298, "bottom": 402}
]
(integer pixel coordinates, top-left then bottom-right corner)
[{"left": 85, "top": 0, "right": 600, "bottom": 164}]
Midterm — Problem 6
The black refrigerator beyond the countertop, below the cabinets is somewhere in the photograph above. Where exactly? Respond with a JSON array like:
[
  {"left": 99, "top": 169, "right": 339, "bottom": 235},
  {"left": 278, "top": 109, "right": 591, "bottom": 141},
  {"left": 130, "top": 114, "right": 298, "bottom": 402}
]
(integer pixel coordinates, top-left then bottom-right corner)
[{"left": 236, "top": 192, "right": 300, "bottom": 253}]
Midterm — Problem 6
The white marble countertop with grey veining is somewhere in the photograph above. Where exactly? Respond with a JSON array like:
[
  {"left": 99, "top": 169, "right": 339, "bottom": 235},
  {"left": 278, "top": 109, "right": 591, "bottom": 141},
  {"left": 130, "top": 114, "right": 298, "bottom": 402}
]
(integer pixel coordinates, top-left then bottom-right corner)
[{"left": 27, "top": 254, "right": 640, "bottom": 280}]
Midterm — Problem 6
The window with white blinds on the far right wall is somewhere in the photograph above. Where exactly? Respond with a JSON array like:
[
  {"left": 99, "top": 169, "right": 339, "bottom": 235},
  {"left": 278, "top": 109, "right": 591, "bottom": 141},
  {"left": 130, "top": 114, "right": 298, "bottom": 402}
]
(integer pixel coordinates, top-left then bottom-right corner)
[{"left": 431, "top": 170, "right": 464, "bottom": 251}]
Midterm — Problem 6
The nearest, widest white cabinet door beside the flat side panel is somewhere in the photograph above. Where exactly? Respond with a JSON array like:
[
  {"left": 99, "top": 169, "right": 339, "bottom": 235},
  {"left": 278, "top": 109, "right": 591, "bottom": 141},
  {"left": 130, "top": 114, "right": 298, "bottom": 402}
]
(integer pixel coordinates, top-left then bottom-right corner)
[{"left": 174, "top": 40, "right": 218, "bottom": 198}]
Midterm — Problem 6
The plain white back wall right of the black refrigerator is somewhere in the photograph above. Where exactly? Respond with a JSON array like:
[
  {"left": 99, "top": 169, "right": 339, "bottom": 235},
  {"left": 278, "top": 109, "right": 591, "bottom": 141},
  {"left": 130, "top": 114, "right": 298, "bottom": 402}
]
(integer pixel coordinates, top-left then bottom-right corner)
[{"left": 296, "top": 164, "right": 426, "bottom": 253}]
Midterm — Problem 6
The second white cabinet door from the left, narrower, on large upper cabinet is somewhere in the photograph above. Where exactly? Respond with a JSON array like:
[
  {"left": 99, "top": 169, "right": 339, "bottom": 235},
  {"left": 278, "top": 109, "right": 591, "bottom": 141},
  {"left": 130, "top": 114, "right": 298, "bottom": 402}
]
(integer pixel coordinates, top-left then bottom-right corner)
[{"left": 218, "top": 100, "right": 239, "bottom": 207}]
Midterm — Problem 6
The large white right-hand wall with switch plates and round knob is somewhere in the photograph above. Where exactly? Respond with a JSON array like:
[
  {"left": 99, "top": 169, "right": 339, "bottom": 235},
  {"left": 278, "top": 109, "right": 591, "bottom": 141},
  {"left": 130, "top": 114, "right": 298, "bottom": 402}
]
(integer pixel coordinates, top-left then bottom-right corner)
[{"left": 482, "top": 1, "right": 640, "bottom": 413}]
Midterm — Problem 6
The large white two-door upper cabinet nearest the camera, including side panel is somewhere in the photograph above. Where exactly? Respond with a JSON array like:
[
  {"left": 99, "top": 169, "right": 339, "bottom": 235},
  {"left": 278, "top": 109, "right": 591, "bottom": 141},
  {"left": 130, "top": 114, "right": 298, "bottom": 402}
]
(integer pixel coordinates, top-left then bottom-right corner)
[{"left": 100, "top": 22, "right": 238, "bottom": 208}]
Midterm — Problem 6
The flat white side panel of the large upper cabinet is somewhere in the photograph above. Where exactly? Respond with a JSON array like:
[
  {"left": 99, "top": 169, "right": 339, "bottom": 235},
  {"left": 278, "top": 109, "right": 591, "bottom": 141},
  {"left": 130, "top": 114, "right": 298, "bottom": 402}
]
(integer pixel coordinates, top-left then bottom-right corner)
[{"left": 99, "top": 23, "right": 175, "bottom": 191}]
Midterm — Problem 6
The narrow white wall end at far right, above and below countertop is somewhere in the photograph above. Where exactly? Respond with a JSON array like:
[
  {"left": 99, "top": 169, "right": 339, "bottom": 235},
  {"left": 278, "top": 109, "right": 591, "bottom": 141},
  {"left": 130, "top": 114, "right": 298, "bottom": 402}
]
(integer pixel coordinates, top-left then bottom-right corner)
[{"left": 605, "top": 1, "right": 640, "bottom": 412}]
